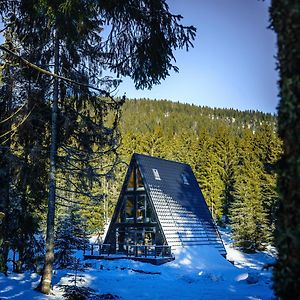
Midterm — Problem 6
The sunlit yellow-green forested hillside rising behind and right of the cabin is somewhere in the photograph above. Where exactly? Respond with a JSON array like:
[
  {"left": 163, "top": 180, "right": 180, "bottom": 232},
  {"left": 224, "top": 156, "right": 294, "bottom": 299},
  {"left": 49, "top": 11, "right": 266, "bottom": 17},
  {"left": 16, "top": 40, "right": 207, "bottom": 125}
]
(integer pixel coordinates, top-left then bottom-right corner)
[{"left": 109, "top": 99, "right": 281, "bottom": 251}]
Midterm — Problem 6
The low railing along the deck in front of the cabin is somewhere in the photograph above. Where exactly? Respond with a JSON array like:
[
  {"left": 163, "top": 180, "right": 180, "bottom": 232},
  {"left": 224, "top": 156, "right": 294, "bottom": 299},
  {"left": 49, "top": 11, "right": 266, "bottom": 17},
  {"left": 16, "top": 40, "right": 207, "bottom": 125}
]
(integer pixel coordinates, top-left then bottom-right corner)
[{"left": 85, "top": 244, "right": 172, "bottom": 258}]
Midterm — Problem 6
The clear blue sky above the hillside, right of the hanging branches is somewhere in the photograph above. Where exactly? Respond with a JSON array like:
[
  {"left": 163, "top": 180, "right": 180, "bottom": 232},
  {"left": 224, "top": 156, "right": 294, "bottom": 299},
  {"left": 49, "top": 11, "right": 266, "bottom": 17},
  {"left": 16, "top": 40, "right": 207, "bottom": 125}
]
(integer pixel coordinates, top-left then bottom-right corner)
[{"left": 0, "top": 0, "right": 278, "bottom": 113}]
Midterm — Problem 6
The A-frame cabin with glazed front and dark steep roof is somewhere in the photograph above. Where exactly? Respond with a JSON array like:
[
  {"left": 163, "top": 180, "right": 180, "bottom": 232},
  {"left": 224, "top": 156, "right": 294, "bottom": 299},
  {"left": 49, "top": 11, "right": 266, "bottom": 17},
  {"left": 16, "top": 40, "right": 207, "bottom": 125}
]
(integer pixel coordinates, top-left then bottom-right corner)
[{"left": 104, "top": 154, "right": 226, "bottom": 262}]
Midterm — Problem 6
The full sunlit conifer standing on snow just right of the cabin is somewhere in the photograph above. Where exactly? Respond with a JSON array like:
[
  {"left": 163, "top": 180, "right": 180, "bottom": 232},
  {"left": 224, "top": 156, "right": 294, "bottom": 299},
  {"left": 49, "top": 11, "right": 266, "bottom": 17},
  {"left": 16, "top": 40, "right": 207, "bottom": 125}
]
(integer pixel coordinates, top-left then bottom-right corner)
[{"left": 230, "top": 131, "right": 270, "bottom": 252}]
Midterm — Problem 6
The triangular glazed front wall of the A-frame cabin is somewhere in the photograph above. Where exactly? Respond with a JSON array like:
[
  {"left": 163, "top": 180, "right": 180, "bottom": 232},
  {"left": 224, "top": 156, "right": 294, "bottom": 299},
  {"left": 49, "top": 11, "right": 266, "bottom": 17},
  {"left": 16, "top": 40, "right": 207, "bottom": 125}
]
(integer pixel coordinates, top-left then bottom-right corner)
[{"left": 104, "top": 156, "right": 167, "bottom": 252}]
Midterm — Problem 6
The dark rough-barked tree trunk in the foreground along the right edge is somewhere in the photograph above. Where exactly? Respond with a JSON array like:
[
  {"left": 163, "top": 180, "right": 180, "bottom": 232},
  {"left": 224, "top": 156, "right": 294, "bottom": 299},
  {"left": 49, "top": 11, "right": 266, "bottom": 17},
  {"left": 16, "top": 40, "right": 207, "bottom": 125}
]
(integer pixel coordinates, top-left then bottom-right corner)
[{"left": 270, "top": 0, "right": 300, "bottom": 300}]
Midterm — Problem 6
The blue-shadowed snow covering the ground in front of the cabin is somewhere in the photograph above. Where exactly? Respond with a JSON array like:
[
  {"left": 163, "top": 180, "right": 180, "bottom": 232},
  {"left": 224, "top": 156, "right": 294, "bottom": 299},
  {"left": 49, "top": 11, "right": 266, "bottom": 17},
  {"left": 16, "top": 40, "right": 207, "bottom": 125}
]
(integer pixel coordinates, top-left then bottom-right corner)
[{"left": 0, "top": 231, "right": 274, "bottom": 300}]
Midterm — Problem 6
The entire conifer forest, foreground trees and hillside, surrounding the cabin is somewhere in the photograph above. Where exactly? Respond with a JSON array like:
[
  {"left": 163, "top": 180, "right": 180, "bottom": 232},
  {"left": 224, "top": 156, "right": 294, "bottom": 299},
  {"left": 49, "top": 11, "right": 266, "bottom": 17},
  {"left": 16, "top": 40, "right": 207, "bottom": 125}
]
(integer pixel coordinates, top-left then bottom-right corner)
[{"left": 0, "top": 0, "right": 300, "bottom": 299}]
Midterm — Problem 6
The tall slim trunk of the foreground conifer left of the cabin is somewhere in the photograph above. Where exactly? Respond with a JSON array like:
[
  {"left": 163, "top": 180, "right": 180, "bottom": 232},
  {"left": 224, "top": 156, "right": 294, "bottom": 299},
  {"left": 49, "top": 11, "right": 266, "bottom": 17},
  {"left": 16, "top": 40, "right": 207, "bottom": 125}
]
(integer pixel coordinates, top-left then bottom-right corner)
[{"left": 38, "top": 32, "right": 59, "bottom": 294}]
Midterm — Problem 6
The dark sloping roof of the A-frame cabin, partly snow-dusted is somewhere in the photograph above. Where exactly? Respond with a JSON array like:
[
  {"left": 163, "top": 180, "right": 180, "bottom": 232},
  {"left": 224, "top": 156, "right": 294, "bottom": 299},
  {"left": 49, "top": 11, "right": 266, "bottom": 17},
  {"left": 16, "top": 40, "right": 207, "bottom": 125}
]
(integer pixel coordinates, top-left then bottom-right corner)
[{"left": 133, "top": 154, "right": 226, "bottom": 254}]
